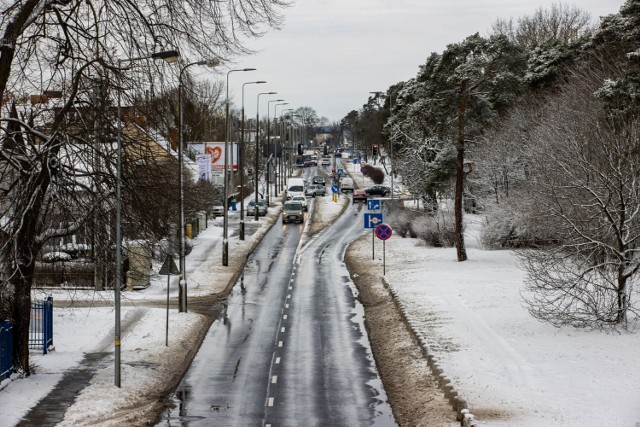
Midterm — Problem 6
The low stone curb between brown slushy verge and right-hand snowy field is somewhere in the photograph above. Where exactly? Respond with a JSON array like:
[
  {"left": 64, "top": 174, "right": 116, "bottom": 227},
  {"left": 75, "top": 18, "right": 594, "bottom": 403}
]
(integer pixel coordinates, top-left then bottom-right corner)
[{"left": 382, "top": 276, "right": 478, "bottom": 427}]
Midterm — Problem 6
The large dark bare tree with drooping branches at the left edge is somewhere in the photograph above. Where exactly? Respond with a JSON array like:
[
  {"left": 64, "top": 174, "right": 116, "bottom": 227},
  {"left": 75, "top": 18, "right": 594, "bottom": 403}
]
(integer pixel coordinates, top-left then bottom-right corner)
[{"left": 0, "top": 0, "right": 286, "bottom": 375}]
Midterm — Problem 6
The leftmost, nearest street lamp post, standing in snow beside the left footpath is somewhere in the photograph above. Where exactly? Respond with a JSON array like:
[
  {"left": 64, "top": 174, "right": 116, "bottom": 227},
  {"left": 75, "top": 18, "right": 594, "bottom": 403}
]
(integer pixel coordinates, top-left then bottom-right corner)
[{"left": 114, "top": 50, "right": 180, "bottom": 387}]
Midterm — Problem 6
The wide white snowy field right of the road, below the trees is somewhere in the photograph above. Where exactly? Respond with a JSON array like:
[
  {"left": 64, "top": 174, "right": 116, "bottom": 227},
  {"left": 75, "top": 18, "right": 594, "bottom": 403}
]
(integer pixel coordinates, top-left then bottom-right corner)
[{"left": 372, "top": 216, "right": 640, "bottom": 427}]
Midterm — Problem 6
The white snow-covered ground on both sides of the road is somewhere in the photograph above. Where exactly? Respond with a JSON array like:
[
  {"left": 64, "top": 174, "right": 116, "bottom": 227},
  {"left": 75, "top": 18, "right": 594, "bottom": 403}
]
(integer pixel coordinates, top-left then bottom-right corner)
[{"left": 0, "top": 165, "right": 640, "bottom": 427}]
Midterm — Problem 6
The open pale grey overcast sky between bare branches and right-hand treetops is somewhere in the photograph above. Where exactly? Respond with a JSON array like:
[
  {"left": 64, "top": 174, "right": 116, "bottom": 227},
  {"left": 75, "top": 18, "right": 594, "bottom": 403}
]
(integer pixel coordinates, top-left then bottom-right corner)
[{"left": 221, "top": 0, "right": 624, "bottom": 121}]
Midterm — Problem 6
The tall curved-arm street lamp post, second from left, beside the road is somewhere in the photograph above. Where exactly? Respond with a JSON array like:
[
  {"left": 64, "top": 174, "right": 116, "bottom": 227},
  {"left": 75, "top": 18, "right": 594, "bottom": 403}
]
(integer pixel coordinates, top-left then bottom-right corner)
[{"left": 178, "top": 59, "right": 220, "bottom": 313}]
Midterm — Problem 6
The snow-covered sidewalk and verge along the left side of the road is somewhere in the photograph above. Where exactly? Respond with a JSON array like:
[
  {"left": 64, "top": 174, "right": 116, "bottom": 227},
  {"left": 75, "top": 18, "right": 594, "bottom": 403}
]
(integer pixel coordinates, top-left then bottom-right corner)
[{"left": 0, "top": 198, "right": 281, "bottom": 427}]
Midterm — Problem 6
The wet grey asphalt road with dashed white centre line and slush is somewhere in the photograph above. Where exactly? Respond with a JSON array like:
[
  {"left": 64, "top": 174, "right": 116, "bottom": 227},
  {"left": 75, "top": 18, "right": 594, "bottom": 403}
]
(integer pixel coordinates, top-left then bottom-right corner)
[{"left": 158, "top": 186, "right": 395, "bottom": 426}]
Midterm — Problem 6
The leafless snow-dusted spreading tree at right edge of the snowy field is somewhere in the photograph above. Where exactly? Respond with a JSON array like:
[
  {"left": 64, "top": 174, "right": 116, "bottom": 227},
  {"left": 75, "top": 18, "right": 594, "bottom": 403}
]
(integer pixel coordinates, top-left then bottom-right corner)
[{"left": 521, "top": 65, "right": 640, "bottom": 327}]
